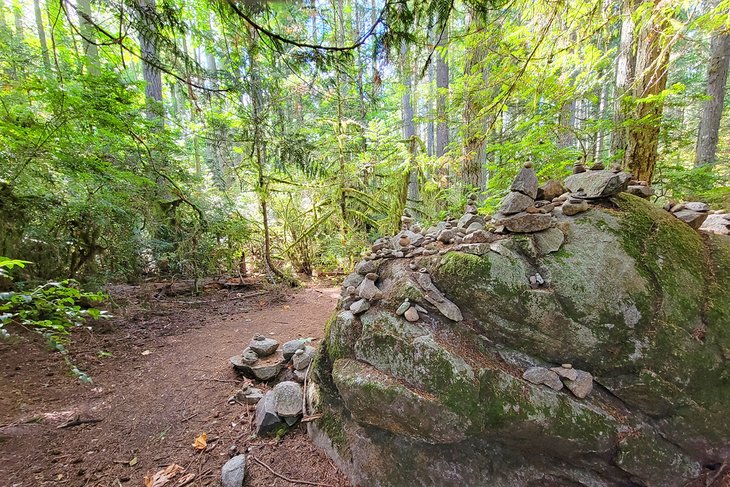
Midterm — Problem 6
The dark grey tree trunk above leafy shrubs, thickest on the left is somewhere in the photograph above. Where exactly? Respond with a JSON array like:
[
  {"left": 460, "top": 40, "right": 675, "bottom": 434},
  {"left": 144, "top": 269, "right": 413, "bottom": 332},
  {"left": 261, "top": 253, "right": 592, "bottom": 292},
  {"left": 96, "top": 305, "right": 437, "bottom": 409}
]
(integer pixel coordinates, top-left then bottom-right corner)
[{"left": 137, "top": 0, "right": 163, "bottom": 125}]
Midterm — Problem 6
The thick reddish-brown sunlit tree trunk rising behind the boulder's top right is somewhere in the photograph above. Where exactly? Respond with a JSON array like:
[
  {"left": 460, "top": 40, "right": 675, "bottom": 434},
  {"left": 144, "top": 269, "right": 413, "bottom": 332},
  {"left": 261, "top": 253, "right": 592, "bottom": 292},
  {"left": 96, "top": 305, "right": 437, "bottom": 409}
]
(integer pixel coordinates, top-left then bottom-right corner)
[{"left": 624, "top": 0, "right": 669, "bottom": 183}]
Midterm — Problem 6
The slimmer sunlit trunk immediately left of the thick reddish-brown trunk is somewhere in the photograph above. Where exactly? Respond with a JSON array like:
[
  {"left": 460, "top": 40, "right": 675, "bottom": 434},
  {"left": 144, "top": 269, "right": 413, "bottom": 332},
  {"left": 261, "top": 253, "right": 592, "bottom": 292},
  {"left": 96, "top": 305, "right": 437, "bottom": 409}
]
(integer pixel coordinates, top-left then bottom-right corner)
[{"left": 611, "top": 0, "right": 638, "bottom": 157}]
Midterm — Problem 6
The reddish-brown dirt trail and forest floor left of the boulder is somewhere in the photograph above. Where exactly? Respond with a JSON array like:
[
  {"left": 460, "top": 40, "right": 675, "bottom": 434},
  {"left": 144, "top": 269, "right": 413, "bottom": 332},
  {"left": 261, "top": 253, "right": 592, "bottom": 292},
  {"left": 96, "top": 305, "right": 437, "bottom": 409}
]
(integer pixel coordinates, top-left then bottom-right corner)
[{"left": 0, "top": 278, "right": 349, "bottom": 487}]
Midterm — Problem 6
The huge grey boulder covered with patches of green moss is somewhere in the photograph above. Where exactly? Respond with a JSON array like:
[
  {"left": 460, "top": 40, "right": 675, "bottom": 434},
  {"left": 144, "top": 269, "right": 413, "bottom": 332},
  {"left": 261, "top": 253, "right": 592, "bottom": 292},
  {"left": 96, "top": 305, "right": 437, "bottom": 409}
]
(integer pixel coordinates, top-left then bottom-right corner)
[{"left": 309, "top": 194, "right": 730, "bottom": 486}]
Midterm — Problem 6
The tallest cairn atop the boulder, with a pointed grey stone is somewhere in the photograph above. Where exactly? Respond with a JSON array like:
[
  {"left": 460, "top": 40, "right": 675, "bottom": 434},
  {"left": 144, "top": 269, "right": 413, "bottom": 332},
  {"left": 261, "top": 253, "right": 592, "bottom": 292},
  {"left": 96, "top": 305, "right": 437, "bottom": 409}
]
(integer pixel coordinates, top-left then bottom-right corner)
[{"left": 494, "top": 162, "right": 553, "bottom": 233}]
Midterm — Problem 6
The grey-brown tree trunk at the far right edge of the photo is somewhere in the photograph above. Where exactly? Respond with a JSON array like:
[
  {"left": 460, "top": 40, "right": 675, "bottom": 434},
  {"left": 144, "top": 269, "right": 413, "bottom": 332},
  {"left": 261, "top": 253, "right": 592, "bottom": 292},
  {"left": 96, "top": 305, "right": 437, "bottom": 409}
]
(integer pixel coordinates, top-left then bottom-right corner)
[{"left": 695, "top": 28, "right": 730, "bottom": 166}]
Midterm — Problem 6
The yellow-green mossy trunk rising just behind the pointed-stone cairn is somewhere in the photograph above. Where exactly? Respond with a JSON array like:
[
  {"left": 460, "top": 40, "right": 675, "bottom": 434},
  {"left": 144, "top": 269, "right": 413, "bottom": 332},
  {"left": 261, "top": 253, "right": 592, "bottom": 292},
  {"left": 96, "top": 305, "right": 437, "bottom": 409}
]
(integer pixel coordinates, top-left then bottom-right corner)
[{"left": 461, "top": 13, "right": 489, "bottom": 194}]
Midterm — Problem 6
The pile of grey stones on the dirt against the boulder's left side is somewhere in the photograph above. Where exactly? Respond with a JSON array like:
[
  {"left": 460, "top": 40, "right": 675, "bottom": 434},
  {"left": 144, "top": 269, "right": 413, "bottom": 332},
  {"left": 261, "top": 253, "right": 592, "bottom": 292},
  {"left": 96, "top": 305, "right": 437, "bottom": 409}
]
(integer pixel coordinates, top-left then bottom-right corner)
[{"left": 228, "top": 334, "right": 316, "bottom": 436}]
